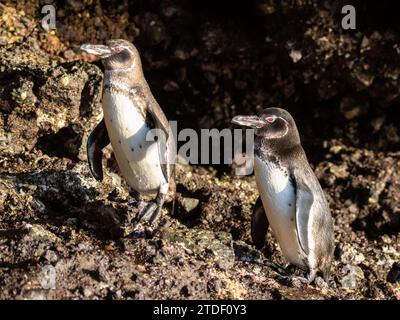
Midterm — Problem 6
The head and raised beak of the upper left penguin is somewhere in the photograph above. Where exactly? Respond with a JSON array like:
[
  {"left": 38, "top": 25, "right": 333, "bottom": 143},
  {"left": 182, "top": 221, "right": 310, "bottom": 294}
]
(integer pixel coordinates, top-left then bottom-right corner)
[{"left": 80, "top": 39, "right": 141, "bottom": 70}]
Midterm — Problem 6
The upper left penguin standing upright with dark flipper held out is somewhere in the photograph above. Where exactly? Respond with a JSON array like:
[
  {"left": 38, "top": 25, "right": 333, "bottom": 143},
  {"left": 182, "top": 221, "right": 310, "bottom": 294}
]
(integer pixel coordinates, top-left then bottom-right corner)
[{"left": 80, "top": 39, "right": 175, "bottom": 225}]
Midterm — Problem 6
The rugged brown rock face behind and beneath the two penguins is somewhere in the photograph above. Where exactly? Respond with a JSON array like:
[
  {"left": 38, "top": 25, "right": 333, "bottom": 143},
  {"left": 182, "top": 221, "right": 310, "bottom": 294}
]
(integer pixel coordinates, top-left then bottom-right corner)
[{"left": 0, "top": 0, "right": 400, "bottom": 299}]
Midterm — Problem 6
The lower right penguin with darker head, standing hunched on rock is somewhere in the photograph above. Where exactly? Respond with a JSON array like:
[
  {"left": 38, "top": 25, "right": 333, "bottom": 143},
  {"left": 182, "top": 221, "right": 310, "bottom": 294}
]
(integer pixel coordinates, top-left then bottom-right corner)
[{"left": 232, "top": 108, "right": 334, "bottom": 284}]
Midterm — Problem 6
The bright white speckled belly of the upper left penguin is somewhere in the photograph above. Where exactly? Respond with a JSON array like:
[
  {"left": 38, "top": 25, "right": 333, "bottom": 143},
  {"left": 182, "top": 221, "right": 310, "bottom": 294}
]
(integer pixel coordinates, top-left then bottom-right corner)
[{"left": 103, "top": 92, "right": 165, "bottom": 193}]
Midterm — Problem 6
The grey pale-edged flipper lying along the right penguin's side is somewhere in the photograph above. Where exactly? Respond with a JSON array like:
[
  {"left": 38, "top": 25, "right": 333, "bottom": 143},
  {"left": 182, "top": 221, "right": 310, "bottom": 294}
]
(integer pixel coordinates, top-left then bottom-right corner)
[{"left": 291, "top": 172, "right": 314, "bottom": 255}]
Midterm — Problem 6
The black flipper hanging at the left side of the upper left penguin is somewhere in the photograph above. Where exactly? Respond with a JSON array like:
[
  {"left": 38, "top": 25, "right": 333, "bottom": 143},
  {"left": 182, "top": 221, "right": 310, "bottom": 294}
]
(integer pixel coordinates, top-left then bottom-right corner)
[{"left": 86, "top": 118, "right": 110, "bottom": 181}]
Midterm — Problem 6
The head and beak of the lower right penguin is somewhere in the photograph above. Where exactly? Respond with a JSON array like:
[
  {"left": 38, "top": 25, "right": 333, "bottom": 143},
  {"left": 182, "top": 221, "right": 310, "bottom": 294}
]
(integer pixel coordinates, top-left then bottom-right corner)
[{"left": 232, "top": 108, "right": 300, "bottom": 144}]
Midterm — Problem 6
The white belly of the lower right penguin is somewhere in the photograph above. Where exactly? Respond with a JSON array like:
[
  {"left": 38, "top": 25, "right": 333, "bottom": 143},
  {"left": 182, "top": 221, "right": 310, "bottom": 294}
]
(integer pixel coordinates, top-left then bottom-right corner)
[{"left": 254, "top": 157, "right": 304, "bottom": 266}]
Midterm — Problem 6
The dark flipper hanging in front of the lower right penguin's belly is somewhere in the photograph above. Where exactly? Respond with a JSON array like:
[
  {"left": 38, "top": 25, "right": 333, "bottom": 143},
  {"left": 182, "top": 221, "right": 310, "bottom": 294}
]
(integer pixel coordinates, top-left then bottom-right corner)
[{"left": 251, "top": 197, "right": 269, "bottom": 249}]
